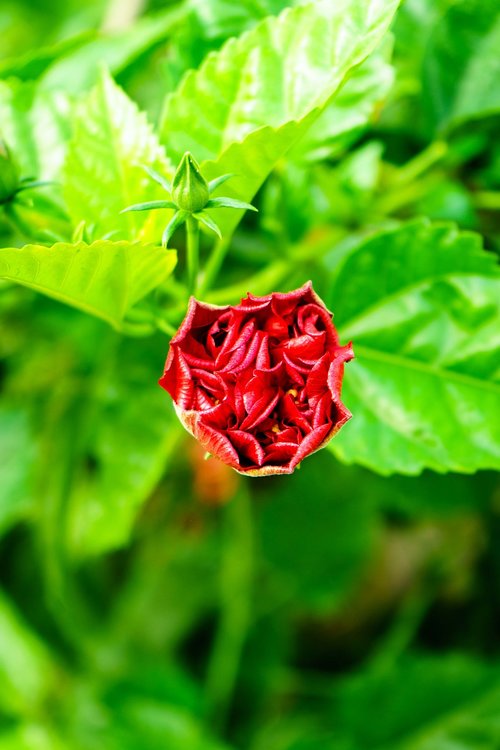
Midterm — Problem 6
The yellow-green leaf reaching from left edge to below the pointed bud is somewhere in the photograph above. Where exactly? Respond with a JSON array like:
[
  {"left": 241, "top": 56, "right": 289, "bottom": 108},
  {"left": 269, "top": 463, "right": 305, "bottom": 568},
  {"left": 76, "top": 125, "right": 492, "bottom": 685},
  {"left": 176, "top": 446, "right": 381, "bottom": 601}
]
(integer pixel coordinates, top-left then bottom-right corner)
[{"left": 0, "top": 240, "right": 177, "bottom": 328}]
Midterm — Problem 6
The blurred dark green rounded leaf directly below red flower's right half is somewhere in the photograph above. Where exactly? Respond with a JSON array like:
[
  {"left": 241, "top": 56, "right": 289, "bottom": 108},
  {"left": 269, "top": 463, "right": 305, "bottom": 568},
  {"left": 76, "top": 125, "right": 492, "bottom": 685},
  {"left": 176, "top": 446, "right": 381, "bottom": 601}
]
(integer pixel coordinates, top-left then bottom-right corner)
[{"left": 258, "top": 451, "right": 378, "bottom": 612}]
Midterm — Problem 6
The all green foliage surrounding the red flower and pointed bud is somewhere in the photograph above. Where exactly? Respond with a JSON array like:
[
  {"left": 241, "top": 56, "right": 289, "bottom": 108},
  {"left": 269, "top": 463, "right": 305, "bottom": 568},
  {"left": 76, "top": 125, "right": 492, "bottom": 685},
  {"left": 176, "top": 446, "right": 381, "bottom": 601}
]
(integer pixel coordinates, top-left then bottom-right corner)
[{"left": 0, "top": 0, "right": 500, "bottom": 750}]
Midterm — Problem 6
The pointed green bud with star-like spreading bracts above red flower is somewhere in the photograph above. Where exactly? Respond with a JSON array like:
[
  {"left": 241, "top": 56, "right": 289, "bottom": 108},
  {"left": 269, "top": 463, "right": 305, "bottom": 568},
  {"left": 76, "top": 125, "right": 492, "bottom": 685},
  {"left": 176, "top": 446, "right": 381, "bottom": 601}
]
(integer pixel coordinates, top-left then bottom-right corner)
[{"left": 121, "top": 151, "right": 257, "bottom": 248}]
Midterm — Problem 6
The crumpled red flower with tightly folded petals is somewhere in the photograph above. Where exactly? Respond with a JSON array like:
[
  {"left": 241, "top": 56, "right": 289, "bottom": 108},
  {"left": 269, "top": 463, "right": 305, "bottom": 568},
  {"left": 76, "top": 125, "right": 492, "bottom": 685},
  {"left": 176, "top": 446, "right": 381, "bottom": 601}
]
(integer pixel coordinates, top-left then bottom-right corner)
[{"left": 160, "top": 282, "right": 354, "bottom": 476}]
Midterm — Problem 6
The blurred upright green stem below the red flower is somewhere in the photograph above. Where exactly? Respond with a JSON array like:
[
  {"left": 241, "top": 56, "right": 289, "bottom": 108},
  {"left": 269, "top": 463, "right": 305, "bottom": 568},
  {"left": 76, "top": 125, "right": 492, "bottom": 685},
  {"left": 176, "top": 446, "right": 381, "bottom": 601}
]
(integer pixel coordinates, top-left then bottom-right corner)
[{"left": 206, "top": 482, "right": 253, "bottom": 732}]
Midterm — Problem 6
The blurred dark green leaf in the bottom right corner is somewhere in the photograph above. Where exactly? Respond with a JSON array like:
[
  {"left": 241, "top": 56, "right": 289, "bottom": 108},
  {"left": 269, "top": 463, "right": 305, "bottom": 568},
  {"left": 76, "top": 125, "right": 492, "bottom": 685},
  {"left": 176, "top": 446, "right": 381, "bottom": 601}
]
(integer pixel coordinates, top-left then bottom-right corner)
[{"left": 331, "top": 653, "right": 500, "bottom": 750}]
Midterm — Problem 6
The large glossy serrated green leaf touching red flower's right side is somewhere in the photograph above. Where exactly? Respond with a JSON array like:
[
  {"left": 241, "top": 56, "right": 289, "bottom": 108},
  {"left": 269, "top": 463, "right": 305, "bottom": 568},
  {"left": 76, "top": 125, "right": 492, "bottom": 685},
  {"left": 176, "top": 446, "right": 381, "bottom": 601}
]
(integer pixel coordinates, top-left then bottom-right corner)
[{"left": 328, "top": 221, "right": 500, "bottom": 474}]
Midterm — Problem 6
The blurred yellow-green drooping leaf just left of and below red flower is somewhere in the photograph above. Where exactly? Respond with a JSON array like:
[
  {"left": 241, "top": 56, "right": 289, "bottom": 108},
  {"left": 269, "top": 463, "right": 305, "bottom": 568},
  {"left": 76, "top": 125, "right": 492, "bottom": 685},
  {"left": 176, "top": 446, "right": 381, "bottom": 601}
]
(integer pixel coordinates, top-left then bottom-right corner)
[{"left": 65, "top": 339, "right": 179, "bottom": 558}]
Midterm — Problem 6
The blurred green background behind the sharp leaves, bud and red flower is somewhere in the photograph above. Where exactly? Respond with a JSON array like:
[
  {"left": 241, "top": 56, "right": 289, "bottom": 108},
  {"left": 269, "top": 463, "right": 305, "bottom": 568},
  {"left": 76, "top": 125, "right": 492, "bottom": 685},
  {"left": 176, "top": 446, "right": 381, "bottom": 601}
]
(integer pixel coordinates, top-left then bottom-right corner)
[{"left": 0, "top": 0, "right": 500, "bottom": 750}]
